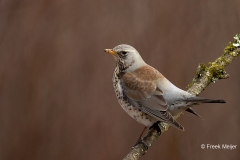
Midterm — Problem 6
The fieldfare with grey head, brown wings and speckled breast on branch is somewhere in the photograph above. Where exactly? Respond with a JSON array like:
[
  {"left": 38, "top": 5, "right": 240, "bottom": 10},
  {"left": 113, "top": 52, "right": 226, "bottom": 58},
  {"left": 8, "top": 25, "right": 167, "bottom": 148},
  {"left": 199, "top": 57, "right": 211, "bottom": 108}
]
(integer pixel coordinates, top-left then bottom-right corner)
[{"left": 104, "top": 44, "right": 225, "bottom": 137}]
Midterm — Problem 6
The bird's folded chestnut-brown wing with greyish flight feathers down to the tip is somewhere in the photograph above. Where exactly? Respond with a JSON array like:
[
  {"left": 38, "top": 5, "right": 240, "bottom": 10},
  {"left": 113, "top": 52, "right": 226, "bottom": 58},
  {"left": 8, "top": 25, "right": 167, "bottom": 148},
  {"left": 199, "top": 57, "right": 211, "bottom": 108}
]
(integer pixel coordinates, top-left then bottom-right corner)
[{"left": 120, "top": 66, "right": 184, "bottom": 130}]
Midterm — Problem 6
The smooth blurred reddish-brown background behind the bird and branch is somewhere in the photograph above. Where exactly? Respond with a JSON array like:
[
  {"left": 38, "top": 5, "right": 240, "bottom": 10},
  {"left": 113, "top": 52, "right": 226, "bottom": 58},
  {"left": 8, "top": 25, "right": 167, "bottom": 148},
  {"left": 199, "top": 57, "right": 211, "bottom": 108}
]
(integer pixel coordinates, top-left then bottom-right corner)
[{"left": 0, "top": 0, "right": 240, "bottom": 160}]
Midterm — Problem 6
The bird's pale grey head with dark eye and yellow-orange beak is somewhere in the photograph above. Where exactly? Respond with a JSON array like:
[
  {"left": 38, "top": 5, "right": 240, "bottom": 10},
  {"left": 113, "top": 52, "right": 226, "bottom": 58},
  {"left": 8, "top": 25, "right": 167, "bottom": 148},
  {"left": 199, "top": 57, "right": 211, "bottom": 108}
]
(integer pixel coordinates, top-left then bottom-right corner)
[{"left": 104, "top": 44, "right": 146, "bottom": 72}]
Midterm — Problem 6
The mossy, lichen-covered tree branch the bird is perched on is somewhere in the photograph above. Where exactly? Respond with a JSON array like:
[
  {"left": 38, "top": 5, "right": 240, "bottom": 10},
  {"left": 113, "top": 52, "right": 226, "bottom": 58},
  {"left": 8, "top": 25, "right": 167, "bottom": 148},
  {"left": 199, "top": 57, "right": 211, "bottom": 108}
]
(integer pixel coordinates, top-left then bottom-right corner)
[{"left": 124, "top": 34, "right": 240, "bottom": 160}]
